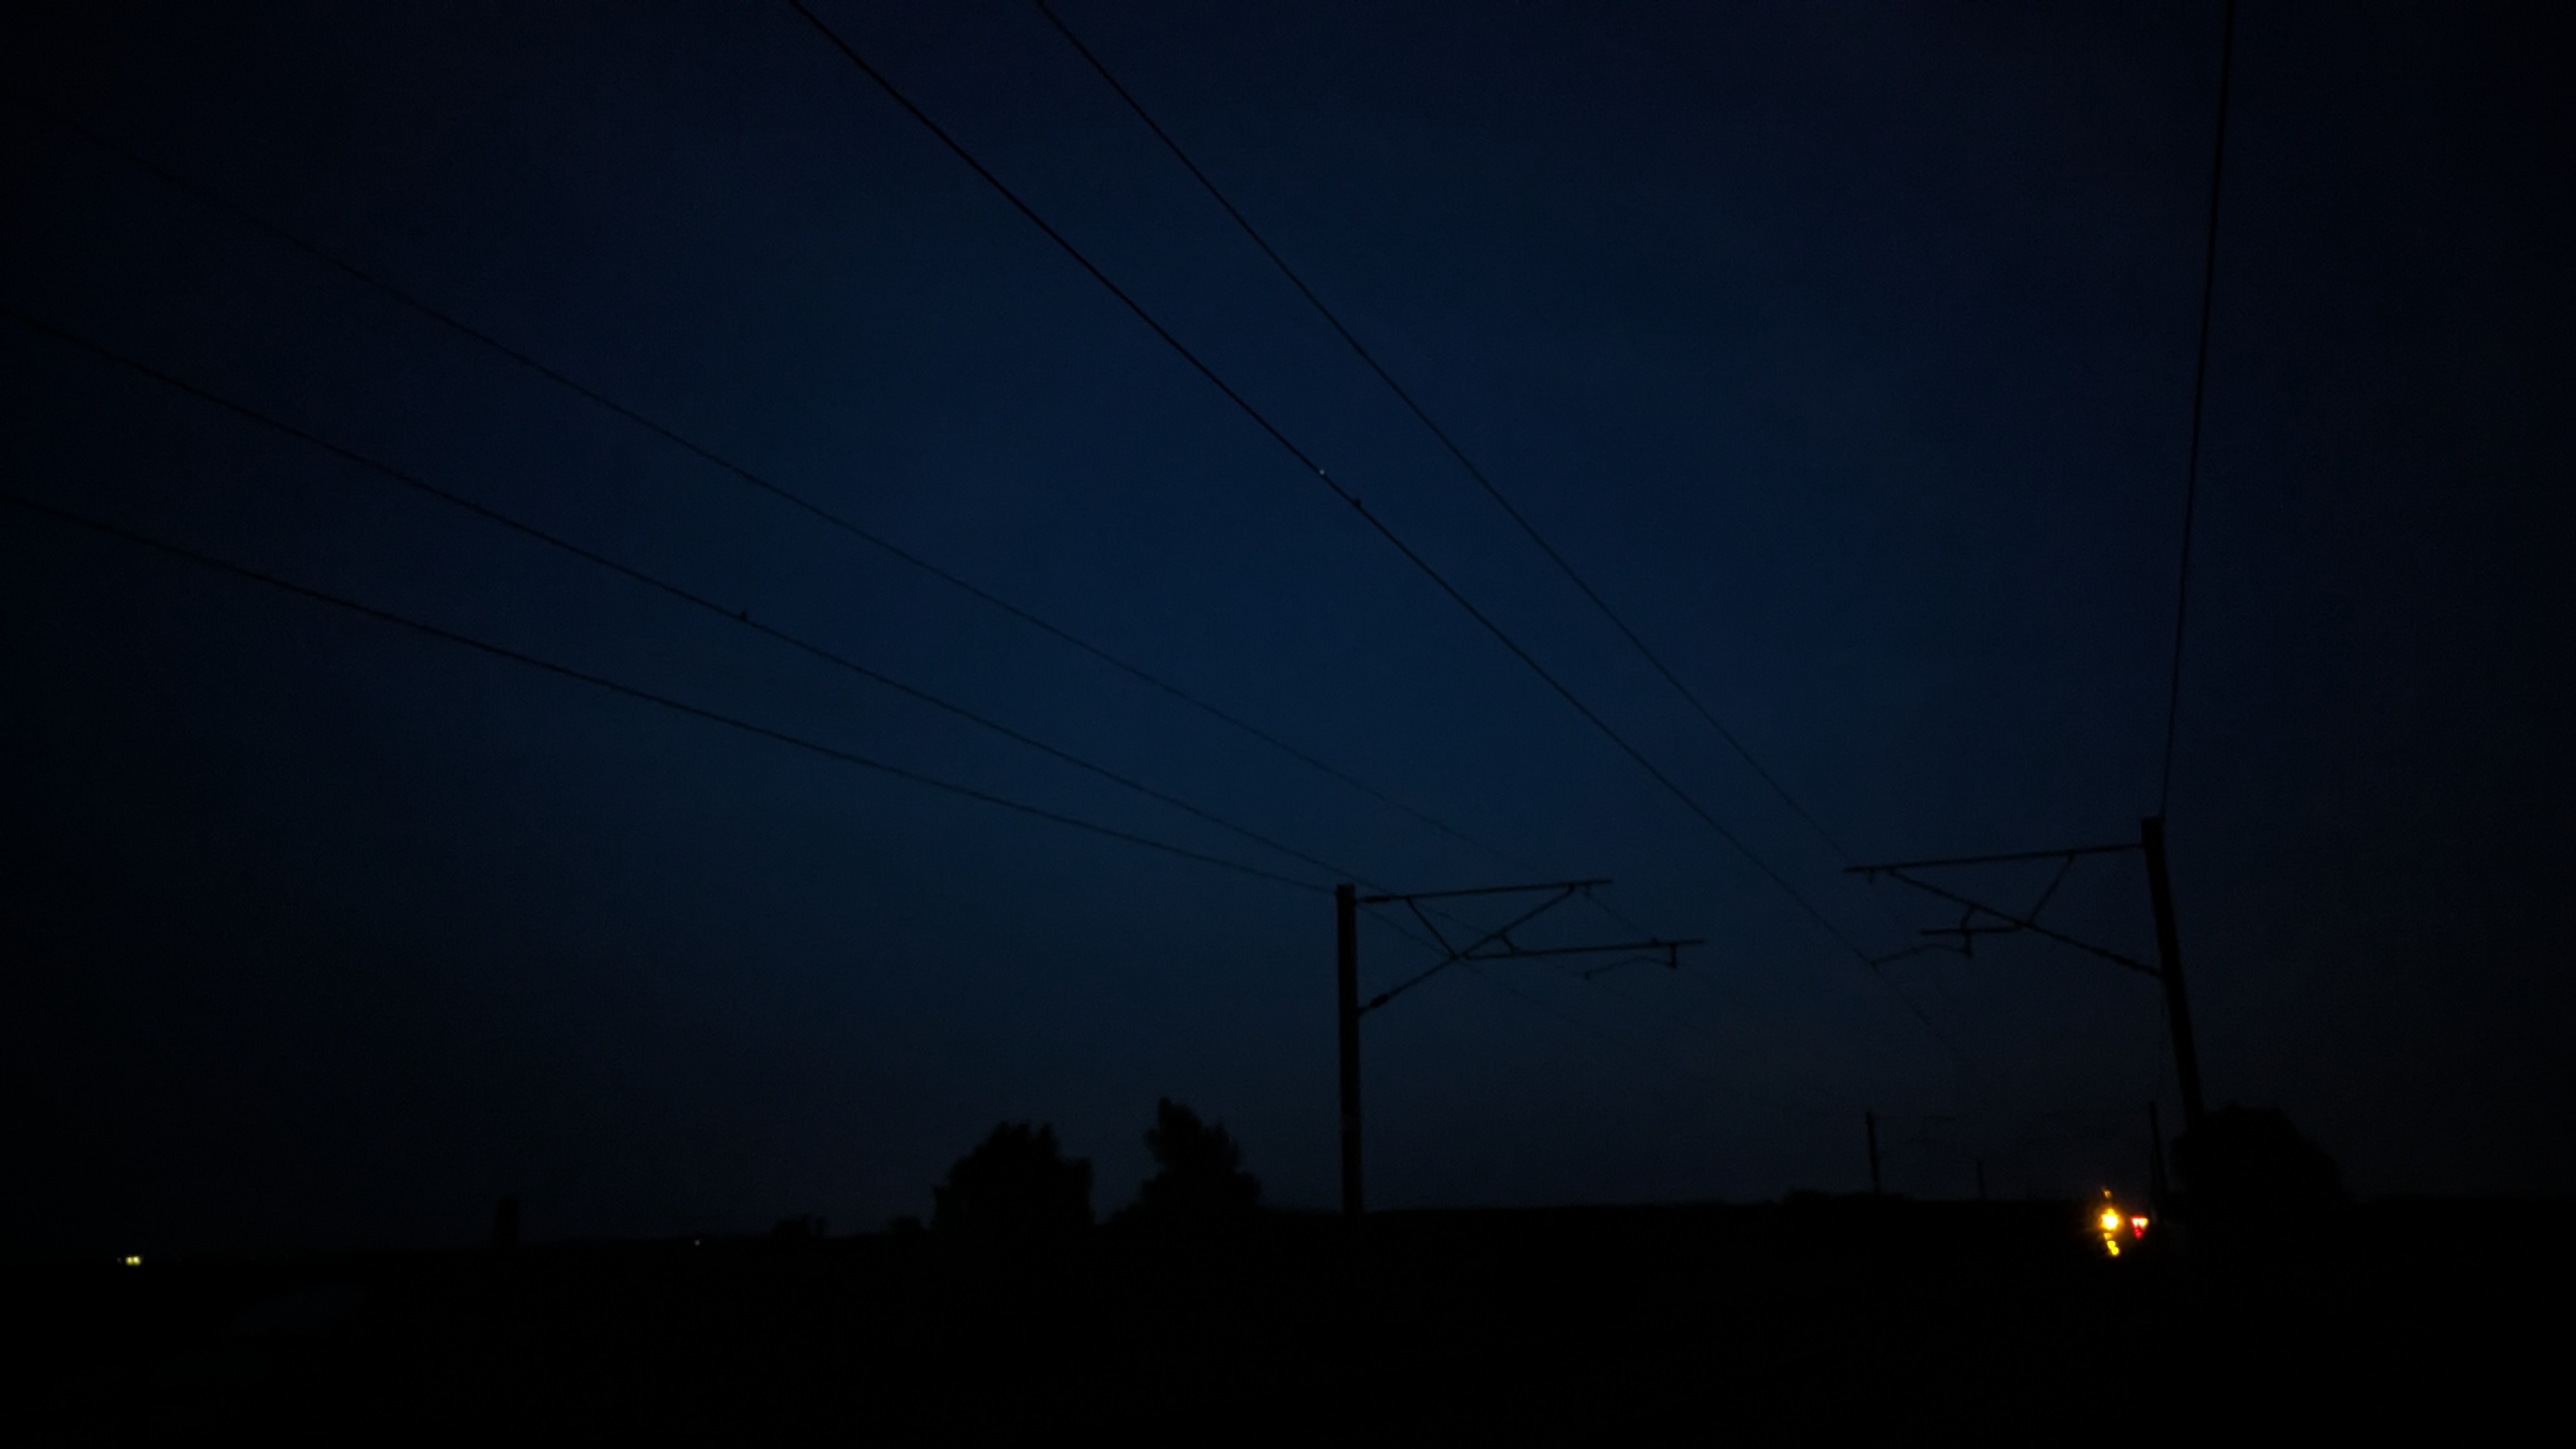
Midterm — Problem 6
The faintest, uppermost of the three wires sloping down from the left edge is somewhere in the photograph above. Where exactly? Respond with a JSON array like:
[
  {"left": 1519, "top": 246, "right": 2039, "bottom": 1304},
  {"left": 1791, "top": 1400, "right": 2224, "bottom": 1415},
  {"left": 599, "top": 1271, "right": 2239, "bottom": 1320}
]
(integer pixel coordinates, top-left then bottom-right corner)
[{"left": 20, "top": 100, "right": 1538, "bottom": 869}]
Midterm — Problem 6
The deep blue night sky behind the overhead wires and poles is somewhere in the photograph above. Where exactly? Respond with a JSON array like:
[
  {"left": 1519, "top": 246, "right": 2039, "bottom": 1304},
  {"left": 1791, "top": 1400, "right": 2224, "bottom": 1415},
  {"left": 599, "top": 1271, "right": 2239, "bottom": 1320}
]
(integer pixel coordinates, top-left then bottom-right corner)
[{"left": 0, "top": 0, "right": 2576, "bottom": 1250}]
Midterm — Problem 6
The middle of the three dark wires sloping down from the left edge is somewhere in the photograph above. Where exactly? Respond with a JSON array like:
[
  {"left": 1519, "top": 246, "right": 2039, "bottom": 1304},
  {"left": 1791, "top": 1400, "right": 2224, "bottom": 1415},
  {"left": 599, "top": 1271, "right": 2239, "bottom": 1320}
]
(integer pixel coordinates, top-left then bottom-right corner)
[{"left": 0, "top": 302, "right": 1411, "bottom": 889}]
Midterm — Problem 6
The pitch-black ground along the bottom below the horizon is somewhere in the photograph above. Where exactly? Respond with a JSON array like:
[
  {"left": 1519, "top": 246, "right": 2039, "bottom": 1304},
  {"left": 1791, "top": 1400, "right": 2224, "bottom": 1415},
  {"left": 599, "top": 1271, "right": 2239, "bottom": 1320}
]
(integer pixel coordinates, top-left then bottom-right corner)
[{"left": 5, "top": 1199, "right": 2571, "bottom": 1444}]
